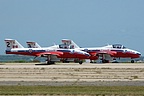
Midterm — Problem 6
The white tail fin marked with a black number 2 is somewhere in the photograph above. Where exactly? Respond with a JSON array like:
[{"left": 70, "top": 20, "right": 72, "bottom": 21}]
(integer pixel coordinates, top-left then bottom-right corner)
[{"left": 5, "top": 39, "right": 24, "bottom": 50}]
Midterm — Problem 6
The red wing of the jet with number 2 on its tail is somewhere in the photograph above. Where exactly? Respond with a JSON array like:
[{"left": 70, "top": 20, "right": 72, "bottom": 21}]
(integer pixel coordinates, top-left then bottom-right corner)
[{"left": 36, "top": 51, "right": 63, "bottom": 57}]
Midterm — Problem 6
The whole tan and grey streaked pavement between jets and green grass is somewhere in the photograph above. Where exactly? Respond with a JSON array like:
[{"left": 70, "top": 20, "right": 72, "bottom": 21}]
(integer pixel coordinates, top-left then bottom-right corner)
[{"left": 0, "top": 63, "right": 144, "bottom": 86}]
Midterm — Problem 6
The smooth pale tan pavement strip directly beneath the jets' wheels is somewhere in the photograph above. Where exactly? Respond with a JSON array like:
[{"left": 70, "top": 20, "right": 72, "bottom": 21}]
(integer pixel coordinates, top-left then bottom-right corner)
[{"left": 0, "top": 63, "right": 144, "bottom": 68}]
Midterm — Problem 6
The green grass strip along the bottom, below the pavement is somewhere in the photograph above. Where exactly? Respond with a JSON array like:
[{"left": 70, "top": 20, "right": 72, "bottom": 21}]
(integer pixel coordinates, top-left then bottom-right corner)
[{"left": 0, "top": 86, "right": 144, "bottom": 96}]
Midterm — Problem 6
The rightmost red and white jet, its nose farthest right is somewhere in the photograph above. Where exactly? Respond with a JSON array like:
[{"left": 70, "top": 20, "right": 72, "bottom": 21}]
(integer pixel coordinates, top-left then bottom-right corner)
[{"left": 60, "top": 39, "right": 141, "bottom": 63}]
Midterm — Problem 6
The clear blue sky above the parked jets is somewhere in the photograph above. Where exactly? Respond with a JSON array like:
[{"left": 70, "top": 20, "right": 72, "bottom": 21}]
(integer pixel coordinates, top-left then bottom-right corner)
[{"left": 0, "top": 0, "right": 144, "bottom": 55}]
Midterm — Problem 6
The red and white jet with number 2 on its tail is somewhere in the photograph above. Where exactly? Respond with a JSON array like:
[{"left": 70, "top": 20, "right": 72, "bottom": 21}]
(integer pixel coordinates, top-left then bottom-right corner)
[{"left": 5, "top": 39, "right": 90, "bottom": 64}]
